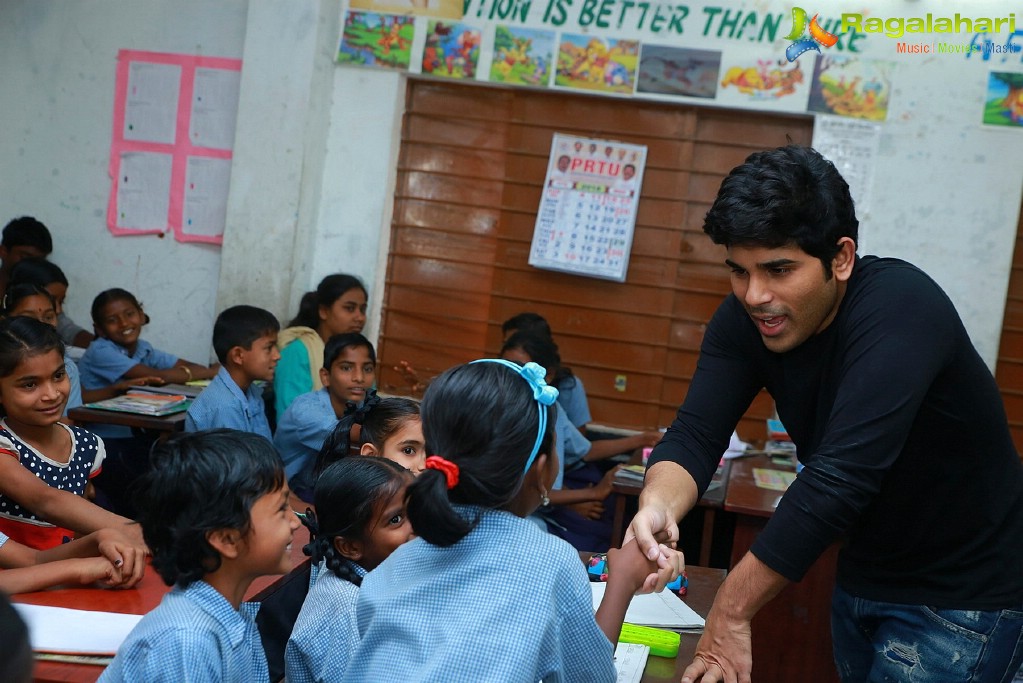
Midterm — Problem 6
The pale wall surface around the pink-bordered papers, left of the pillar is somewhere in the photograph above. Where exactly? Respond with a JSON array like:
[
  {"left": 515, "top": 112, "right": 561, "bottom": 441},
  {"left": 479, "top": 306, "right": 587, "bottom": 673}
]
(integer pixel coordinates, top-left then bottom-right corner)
[{"left": 0, "top": 0, "right": 247, "bottom": 361}]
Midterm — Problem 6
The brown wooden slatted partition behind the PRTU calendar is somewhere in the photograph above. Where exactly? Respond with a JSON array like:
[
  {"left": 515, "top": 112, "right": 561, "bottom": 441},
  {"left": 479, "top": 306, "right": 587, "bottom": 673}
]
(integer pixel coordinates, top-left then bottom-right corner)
[{"left": 379, "top": 80, "right": 812, "bottom": 439}]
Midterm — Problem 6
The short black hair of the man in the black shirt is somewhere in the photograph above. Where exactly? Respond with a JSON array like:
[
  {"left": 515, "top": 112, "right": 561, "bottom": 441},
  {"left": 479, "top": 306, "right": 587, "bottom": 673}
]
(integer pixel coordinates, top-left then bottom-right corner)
[{"left": 704, "top": 145, "right": 859, "bottom": 278}]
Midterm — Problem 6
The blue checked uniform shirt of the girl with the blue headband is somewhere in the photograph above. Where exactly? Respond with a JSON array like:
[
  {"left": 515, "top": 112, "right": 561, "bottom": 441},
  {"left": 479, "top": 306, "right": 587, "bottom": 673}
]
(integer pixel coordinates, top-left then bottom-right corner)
[{"left": 343, "top": 506, "right": 617, "bottom": 683}]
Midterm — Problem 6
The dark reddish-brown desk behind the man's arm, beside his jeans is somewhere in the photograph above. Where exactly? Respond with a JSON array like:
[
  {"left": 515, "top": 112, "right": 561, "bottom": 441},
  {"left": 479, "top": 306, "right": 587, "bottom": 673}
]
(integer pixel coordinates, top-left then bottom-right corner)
[{"left": 724, "top": 455, "right": 839, "bottom": 683}]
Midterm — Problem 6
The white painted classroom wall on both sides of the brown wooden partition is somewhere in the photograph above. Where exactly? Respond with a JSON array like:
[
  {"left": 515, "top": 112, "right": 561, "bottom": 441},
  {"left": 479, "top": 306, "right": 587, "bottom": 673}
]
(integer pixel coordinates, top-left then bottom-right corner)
[{"left": 0, "top": 0, "right": 1023, "bottom": 374}]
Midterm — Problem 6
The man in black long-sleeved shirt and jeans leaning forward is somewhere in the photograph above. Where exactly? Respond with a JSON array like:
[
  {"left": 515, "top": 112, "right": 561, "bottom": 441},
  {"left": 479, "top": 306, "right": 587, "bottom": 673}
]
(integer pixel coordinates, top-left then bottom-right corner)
[{"left": 630, "top": 146, "right": 1023, "bottom": 683}]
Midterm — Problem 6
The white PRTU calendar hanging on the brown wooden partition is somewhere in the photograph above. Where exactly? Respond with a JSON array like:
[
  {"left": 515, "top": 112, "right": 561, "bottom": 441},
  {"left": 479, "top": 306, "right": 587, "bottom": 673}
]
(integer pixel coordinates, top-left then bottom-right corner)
[{"left": 529, "top": 133, "right": 647, "bottom": 282}]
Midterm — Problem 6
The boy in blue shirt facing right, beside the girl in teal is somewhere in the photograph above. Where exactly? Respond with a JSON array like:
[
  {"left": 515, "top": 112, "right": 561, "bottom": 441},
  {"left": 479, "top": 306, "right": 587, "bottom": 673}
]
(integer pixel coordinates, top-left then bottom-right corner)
[{"left": 185, "top": 306, "right": 280, "bottom": 440}]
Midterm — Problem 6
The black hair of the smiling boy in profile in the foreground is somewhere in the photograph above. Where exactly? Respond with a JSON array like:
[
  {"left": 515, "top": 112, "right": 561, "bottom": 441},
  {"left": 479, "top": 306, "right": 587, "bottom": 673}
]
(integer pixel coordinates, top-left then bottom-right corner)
[{"left": 135, "top": 429, "right": 284, "bottom": 588}]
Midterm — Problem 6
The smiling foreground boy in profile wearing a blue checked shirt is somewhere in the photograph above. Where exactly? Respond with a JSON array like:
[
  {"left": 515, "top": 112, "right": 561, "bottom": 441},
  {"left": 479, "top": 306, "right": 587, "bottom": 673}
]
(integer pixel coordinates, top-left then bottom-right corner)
[{"left": 99, "top": 429, "right": 299, "bottom": 683}]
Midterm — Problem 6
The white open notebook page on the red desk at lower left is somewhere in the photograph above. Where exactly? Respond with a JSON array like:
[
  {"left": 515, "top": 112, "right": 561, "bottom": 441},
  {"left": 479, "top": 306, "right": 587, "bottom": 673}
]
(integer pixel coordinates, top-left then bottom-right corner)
[{"left": 14, "top": 603, "right": 142, "bottom": 655}]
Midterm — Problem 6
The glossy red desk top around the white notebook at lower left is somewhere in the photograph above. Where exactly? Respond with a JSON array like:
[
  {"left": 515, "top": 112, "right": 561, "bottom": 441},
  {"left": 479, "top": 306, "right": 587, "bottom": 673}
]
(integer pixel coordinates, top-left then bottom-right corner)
[{"left": 18, "top": 527, "right": 309, "bottom": 683}]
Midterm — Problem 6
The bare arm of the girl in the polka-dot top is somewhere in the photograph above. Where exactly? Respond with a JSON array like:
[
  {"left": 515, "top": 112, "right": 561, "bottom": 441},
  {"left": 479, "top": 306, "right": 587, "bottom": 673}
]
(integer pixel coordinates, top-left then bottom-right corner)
[{"left": 0, "top": 452, "right": 145, "bottom": 552}]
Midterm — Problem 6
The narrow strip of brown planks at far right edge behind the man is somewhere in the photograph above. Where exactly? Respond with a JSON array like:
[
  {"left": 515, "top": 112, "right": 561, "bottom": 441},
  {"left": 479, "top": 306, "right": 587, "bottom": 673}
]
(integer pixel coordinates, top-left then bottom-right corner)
[{"left": 994, "top": 208, "right": 1023, "bottom": 457}]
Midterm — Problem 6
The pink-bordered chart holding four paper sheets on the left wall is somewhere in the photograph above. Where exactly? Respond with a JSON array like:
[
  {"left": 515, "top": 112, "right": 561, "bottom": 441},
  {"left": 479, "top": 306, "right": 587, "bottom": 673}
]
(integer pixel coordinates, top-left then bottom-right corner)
[{"left": 106, "top": 50, "right": 241, "bottom": 244}]
